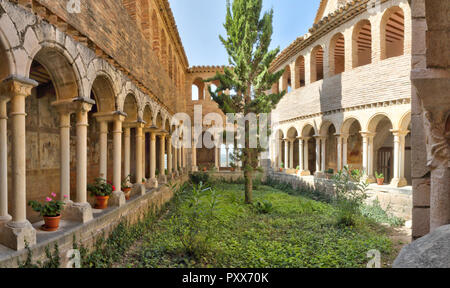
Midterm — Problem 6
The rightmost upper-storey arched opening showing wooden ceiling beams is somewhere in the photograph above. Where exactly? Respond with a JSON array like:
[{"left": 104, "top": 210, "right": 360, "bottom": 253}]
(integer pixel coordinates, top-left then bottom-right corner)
[{"left": 380, "top": 6, "right": 406, "bottom": 60}]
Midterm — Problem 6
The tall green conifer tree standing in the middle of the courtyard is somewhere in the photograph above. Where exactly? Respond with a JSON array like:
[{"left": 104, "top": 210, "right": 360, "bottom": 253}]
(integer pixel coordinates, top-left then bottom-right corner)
[{"left": 205, "top": 0, "right": 284, "bottom": 204}]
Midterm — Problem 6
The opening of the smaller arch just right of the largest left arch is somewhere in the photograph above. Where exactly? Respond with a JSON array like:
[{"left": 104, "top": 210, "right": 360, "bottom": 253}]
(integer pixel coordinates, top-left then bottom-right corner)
[{"left": 91, "top": 73, "right": 117, "bottom": 113}]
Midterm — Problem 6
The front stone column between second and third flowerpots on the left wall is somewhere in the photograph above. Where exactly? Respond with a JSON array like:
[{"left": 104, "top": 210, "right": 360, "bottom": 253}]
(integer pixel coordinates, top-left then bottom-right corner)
[{"left": 110, "top": 114, "right": 126, "bottom": 207}]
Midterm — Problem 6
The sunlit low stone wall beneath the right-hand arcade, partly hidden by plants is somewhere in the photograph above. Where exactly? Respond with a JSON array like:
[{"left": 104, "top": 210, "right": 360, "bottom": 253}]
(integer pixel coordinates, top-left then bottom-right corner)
[{"left": 269, "top": 172, "right": 412, "bottom": 221}]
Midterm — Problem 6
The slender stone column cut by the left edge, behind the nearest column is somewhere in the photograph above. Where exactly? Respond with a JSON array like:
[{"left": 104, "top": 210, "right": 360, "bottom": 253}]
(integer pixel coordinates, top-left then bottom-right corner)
[{"left": 0, "top": 95, "right": 12, "bottom": 224}]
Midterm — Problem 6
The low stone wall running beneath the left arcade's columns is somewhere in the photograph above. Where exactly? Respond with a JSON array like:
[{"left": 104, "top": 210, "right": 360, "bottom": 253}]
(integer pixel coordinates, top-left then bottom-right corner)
[{"left": 0, "top": 175, "right": 187, "bottom": 268}]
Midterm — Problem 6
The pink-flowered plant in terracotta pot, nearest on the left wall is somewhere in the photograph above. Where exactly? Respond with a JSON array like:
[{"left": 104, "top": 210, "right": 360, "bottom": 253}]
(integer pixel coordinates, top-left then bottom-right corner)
[{"left": 28, "top": 193, "right": 68, "bottom": 231}]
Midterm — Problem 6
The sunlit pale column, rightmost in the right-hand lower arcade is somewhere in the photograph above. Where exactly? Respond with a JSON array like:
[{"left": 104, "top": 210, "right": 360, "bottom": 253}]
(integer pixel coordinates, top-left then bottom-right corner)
[{"left": 391, "top": 130, "right": 409, "bottom": 187}]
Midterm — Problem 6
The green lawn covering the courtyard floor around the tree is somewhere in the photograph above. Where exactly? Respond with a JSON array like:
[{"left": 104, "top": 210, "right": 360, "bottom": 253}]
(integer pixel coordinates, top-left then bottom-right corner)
[{"left": 95, "top": 184, "right": 395, "bottom": 268}]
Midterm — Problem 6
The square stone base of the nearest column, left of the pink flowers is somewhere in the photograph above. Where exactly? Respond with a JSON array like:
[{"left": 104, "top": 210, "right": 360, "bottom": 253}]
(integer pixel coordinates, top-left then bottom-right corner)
[{"left": 0, "top": 220, "right": 36, "bottom": 251}]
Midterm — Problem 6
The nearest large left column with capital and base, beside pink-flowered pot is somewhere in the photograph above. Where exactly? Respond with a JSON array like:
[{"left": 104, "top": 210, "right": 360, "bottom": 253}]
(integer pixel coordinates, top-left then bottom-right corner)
[{"left": 0, "top": 77, "right": 38, "bottom": 250}]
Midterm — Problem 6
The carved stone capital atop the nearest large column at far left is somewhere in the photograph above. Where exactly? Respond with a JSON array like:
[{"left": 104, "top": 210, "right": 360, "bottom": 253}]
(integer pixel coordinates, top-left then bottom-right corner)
[{"left": 0, "top": 75, "right": 39, "bottom": 100}]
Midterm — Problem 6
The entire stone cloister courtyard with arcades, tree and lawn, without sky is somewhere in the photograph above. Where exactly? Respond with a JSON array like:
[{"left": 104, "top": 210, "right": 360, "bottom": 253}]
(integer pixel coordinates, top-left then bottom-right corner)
[{"left": 0, "top": 0, "right": 450, "bottom": 268}]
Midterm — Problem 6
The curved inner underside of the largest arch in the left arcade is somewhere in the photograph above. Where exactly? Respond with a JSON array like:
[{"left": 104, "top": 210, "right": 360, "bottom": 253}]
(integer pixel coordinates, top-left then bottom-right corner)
[{"left": 27, "top": 45, "right": 81, "bottom": 100}]
